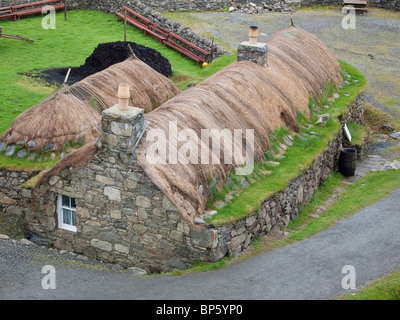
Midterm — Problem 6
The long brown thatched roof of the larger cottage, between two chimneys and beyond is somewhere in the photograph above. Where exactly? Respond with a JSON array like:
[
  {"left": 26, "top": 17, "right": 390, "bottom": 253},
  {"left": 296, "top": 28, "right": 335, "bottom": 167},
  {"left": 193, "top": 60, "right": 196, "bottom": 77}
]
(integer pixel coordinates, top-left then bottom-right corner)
[{"left": 136, "top": 27, "right": 343, "bottom": 223}]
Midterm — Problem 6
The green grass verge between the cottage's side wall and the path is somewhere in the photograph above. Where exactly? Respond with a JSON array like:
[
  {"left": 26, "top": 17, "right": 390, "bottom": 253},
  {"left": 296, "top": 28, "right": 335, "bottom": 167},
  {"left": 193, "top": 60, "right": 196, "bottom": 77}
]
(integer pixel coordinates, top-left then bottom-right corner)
[{"left": 167, "top": 170, "right": 400, "bottom": 276}]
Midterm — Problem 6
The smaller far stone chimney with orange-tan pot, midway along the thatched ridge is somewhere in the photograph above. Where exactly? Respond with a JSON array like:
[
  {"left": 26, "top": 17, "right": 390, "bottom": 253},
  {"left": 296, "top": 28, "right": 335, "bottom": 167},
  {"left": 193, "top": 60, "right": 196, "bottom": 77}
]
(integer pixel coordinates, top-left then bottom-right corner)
[{"left": 237, "top": 26, "right": 268, "bottom": 66}]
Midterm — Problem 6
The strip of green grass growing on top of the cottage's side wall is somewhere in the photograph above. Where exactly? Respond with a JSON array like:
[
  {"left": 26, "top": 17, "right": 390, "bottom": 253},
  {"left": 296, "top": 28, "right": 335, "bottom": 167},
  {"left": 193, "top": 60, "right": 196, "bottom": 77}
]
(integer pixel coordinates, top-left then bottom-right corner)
[{"left": 207, "top": 62, "right": 366, "bottom": 226}]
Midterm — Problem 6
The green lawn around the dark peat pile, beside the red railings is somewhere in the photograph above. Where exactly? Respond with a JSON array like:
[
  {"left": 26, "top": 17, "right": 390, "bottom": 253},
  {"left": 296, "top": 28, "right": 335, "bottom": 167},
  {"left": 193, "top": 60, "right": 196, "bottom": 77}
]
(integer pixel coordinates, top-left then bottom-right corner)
[{"left": 0, "top": 10, "right": 236, "bottom": 168}]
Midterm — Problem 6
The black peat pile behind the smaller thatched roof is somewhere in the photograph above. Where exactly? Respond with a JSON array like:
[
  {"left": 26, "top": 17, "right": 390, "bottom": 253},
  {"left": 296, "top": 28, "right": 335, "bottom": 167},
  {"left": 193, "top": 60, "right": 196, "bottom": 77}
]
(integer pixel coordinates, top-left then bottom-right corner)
[{"left": 34, "top": 41, "right": 172, "bottom": 85}]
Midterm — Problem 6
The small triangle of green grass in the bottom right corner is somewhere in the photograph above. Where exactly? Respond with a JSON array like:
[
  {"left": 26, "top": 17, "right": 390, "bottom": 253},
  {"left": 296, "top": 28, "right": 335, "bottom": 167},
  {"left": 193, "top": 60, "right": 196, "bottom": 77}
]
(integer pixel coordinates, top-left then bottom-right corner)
[{"left": 345, "top": 270, "right": 400, "bottom": 300}]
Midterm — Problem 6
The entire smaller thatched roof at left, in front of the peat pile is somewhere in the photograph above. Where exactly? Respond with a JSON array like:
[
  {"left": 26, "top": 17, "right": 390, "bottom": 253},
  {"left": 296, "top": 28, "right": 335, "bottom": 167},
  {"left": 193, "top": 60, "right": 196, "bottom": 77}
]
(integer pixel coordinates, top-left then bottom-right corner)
[{"left": 0, "top": 59, "right": 179, "bottom": 150}]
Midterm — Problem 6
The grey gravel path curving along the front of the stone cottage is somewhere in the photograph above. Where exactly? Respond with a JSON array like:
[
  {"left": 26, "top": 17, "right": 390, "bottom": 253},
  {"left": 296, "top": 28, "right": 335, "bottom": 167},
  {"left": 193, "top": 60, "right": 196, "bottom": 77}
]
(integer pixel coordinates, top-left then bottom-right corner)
[{"left": 0, "top": 189, "right": 400, "bottom": 300}]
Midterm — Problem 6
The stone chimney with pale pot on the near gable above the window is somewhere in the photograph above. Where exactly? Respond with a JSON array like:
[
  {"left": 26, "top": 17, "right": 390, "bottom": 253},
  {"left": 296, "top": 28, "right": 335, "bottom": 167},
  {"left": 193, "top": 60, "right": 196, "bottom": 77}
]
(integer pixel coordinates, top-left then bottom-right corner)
[{"left": 101, "top": 87, "right": 147, "bottom": 164}]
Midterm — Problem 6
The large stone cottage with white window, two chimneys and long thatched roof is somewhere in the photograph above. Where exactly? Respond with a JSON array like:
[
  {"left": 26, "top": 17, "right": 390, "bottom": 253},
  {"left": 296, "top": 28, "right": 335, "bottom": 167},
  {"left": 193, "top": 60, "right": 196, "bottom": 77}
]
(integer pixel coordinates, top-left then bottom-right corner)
[{"left": 0, "top": 27, "right": 363, "bottom": 272}]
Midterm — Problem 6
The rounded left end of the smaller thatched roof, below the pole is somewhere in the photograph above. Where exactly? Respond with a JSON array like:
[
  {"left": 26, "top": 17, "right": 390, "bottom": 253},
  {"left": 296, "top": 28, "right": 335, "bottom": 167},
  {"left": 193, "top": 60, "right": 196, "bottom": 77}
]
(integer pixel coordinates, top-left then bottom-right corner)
[{"left": 1, "top": 85, "right": 100, "bottom": 150}]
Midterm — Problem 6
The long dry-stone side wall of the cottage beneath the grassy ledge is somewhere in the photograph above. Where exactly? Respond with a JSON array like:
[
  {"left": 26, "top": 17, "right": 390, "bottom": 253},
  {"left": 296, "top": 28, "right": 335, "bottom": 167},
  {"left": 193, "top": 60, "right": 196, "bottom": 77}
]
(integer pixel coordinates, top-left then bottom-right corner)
[{"left": 205, "top": 93, "right": 365, "bottom": 261}]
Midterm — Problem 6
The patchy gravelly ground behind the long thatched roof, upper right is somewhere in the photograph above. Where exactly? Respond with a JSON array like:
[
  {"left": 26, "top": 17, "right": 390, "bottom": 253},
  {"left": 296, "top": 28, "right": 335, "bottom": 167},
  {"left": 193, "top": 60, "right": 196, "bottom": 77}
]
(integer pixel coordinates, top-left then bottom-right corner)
[{"left": 168, "top": 8, "right": 400, "bottom": 119}]
